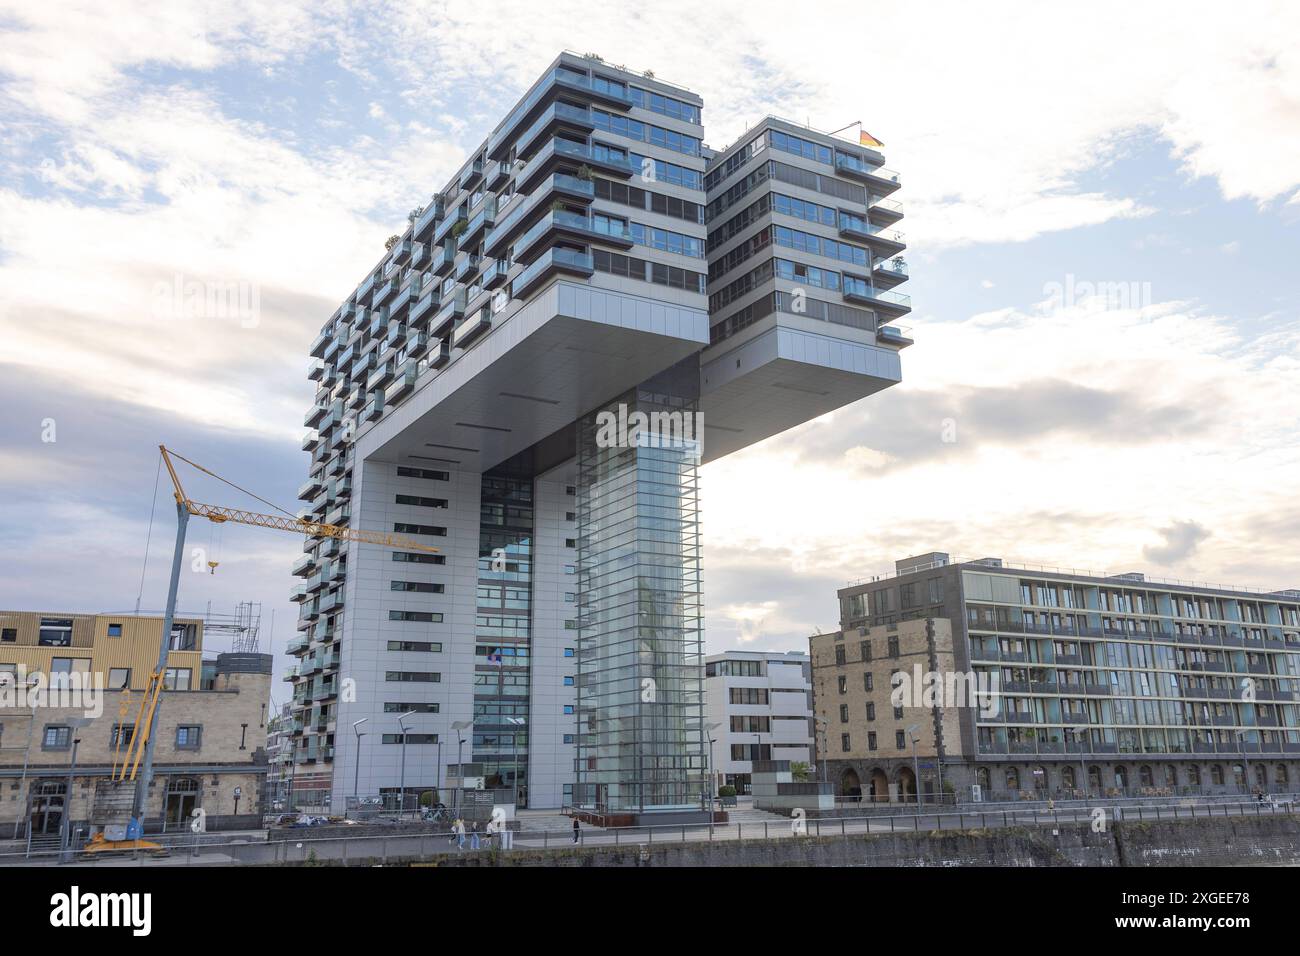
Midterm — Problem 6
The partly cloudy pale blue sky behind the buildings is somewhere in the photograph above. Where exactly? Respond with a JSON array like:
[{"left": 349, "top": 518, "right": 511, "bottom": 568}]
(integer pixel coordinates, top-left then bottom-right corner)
[{"left": 0, "top": 0, "right": 1300, "bottom": 697}]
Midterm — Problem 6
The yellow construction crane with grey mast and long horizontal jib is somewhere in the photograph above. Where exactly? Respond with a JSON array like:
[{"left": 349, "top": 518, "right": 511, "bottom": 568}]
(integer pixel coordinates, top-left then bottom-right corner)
[{"left": 86, "top": 445, "right": 438, "bottom": 853}]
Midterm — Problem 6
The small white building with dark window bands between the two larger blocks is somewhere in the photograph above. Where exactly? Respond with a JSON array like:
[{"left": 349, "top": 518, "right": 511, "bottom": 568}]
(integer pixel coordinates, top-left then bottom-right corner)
[{"left": 705, "top": 650, "right": 814, "bottom": 793}]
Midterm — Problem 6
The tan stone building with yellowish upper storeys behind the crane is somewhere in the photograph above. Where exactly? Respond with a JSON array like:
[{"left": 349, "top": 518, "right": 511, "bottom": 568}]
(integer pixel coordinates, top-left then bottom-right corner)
[{"left": 0, "top": 611, "right": 272, "bottom": 842}]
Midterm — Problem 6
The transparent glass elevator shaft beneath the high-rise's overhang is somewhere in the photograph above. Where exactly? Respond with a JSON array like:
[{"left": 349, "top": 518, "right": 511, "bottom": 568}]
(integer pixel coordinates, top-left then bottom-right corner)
[{"left": 575, "top": 360, "right": 706, "bottom": 813}]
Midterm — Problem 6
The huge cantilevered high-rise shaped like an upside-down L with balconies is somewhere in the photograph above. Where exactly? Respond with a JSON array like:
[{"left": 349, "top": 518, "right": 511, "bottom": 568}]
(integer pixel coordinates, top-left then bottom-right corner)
[{"left": 290, "top": 53, "right": 907, "bottom": 817}]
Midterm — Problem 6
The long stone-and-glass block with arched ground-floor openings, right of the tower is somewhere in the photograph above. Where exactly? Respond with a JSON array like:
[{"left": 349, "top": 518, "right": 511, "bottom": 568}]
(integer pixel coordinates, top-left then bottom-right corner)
[{"left": 811, "top": 551, "right": 1300, "bottom": 800}]
